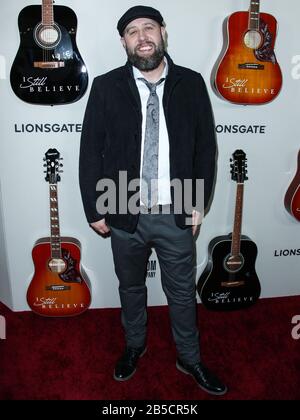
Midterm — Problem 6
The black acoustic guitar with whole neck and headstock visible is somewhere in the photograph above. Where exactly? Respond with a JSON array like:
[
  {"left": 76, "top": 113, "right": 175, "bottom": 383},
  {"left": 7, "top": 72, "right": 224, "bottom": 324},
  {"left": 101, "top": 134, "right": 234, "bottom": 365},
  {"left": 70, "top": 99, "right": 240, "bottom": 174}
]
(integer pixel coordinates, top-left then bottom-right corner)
[{"left": 197, "top": 150, "right": 261, "bottom": 311}]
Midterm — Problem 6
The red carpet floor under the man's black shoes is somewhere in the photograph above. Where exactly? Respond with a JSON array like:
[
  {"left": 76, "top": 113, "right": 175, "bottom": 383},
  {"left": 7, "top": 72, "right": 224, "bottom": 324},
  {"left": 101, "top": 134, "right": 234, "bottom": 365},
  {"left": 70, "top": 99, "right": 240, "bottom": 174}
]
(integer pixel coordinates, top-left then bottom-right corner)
[{"left": 0, "top": 296, "right": 300, "bottom": 400}]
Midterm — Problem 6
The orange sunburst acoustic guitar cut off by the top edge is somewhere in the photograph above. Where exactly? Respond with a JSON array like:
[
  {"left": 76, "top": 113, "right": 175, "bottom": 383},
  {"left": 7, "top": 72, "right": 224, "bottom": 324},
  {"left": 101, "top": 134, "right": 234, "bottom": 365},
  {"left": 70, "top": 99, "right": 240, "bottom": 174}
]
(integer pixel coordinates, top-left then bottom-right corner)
[{"left": 214, "top": 0, "right": 282, "bottom": 105}]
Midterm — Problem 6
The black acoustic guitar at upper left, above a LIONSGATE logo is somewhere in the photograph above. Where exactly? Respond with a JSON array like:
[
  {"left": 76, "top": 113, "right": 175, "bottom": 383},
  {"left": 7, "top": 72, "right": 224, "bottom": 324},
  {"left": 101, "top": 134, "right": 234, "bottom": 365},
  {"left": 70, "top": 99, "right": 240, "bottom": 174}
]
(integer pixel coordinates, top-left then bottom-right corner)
[{"left": 10, "top": 0, "right": 88, "bottom": 105}]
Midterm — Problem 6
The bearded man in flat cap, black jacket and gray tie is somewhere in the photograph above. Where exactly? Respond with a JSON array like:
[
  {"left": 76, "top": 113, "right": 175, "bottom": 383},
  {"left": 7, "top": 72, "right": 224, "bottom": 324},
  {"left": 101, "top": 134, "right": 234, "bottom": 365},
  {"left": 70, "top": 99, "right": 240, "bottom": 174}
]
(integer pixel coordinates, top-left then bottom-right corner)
[{"left": 80, "top": 6, "right": 227, "bottom": 395}]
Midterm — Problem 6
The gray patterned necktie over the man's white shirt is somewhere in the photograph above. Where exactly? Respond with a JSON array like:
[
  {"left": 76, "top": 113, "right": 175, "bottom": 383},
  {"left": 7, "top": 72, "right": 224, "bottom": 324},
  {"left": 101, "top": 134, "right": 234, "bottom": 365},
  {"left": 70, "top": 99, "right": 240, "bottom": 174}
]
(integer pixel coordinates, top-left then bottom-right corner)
[{"left": 139, "top": 78, "right": 165, "bottom": 208}]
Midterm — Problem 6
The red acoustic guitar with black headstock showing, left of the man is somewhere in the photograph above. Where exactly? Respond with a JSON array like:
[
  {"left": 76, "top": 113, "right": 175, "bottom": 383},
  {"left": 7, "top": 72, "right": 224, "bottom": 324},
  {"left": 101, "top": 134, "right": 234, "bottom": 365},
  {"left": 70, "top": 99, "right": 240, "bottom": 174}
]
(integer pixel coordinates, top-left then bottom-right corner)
[{"left": 27, "top": 149, "right": 91, "bottom": 317}]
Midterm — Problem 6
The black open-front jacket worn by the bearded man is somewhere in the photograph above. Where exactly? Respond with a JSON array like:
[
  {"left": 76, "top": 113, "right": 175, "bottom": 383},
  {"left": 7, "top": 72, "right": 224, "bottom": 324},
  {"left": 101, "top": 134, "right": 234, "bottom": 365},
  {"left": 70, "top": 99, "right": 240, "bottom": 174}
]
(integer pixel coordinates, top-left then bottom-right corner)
[{"left": 79, "top": 54, "right": 216, "bottom": 232}]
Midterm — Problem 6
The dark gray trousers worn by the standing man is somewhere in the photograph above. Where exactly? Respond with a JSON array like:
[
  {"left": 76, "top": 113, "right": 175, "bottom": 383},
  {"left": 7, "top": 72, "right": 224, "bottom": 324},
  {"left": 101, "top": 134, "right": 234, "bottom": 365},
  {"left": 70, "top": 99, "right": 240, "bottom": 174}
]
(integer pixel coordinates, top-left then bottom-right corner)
[{"left": 111, "top": 214, "right": 200, "bottom": 364}]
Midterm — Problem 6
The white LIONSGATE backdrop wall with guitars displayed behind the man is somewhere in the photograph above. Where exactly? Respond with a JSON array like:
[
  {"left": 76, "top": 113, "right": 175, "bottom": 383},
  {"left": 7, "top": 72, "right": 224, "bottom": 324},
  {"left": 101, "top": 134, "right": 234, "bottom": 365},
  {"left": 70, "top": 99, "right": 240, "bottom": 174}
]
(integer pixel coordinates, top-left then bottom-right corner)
[{"left": 0, "top": 0, "right": 300, "bottom": 315}]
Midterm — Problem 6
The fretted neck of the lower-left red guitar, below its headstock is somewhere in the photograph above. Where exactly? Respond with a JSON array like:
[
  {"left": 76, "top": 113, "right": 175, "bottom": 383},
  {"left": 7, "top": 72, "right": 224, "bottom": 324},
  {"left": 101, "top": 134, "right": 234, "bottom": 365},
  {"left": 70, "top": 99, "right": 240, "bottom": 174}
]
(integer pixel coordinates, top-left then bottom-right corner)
[{"left": 49, "top": 184, "right": 61, "bottom": 258}]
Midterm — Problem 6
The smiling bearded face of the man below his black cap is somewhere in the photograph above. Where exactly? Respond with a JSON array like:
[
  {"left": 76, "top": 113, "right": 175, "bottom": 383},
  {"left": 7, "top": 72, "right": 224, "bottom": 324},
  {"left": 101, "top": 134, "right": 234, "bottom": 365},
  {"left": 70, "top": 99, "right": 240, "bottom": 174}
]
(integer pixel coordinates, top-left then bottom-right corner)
[{"left": 121, "top": 18, "right": 165, "bottom": 71}]
